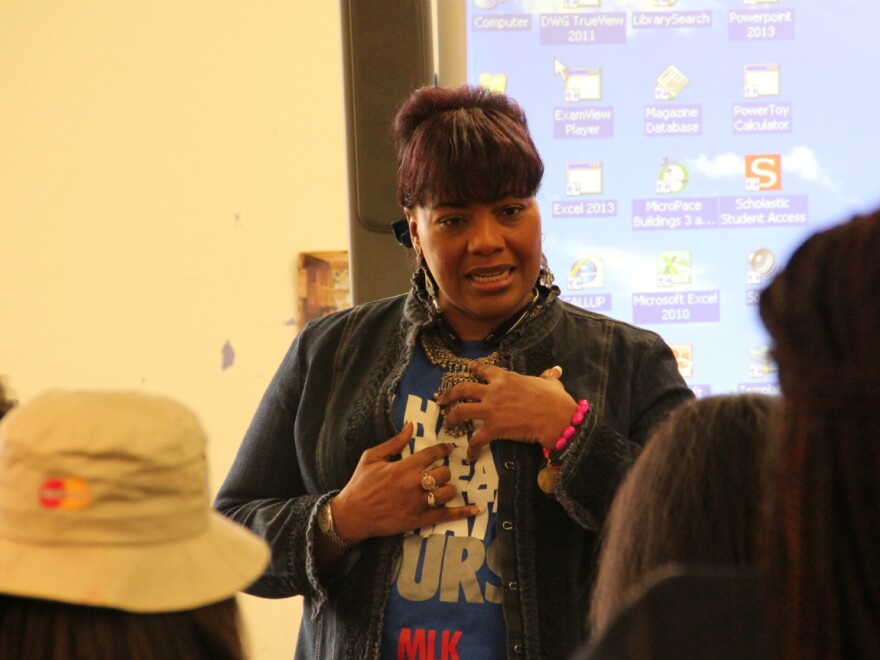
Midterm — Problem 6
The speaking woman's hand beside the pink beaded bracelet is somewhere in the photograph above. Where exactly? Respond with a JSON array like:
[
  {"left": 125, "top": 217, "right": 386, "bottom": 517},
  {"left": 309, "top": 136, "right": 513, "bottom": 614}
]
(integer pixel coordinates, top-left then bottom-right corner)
[{"left": 437, "top": 362, "right": 577, "bottom": 462}]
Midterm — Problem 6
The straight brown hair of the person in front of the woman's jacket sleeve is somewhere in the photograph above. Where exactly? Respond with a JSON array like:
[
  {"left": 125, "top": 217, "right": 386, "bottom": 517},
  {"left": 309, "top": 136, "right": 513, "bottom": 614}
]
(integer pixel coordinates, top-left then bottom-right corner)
[{"left": 590, "top": 394, "right": 779, "bottom": 635}]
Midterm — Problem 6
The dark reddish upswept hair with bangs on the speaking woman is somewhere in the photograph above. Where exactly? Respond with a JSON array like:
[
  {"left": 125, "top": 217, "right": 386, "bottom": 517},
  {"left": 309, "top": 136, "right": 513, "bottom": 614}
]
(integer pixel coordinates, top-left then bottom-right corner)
[{"left": 392, "top": 86, "right": 544, "bottom": 208}]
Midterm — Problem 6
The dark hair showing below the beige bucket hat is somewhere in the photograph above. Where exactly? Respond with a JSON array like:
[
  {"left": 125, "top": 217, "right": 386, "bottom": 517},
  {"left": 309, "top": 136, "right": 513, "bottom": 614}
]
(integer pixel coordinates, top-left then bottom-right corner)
[{"left": 0, "top": 595, "right": 245, "bottom": 660}]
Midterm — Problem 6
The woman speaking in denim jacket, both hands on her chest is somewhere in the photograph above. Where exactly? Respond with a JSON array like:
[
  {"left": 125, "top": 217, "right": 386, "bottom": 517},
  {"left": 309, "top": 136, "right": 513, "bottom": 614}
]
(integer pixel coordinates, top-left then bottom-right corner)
[{"left": 216, "top": 87, "right": 693, "bottom": 660}]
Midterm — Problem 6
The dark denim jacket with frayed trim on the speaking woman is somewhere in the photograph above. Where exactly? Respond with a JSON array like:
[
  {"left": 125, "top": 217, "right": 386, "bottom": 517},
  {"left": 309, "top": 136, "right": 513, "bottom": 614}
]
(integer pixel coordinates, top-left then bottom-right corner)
[{"left": 216, "top": 288, "right": 693, "bottom": 660}]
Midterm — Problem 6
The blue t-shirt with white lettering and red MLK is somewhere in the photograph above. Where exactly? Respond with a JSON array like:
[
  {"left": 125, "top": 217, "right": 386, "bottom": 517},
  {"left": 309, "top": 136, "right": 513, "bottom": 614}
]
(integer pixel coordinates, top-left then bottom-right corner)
[{"left": 382, "top": 342, "right": 507, "bottom": 660}]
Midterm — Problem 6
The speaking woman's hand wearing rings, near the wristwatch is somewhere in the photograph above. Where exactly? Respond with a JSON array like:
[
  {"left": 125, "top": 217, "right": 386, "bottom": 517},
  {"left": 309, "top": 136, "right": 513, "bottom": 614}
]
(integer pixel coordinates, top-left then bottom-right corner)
[{"left": 331, "top": 422, "right": 480, "bottom": 544}]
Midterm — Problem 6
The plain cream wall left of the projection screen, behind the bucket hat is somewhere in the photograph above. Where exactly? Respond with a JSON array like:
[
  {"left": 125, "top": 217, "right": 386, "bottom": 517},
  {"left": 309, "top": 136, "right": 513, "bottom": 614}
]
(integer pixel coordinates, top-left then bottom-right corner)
[{"left": 0, "top": 0, "right": 348, "bottom": 660}]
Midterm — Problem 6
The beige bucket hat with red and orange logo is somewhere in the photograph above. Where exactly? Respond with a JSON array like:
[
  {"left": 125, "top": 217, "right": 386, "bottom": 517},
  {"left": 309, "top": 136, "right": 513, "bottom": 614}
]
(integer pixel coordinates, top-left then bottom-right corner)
[{"left": 0, "top": 391, "right": 268, "bottom": 612}]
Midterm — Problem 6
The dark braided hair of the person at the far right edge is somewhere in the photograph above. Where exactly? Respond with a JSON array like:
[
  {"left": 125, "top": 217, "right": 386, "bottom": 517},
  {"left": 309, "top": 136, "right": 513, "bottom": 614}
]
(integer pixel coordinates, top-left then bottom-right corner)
[{"left": 760, "top": 213, "right": 880, "bottom": 660}]
